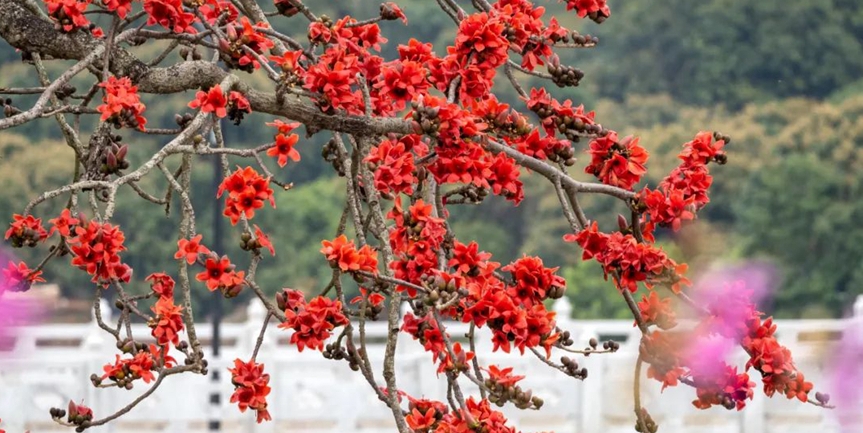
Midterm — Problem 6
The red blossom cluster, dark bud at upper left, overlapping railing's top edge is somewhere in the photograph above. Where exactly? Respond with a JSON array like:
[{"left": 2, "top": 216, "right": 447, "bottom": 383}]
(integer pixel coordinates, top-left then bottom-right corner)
[{"left": 278, "top": 289, "right": 349, "bottom": 352}]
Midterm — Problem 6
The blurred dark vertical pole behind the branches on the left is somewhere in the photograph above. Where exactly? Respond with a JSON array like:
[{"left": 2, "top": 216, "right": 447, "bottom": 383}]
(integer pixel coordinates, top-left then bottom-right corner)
[{"left": 209, "top": 133, "right": 225, "bottom": 431}]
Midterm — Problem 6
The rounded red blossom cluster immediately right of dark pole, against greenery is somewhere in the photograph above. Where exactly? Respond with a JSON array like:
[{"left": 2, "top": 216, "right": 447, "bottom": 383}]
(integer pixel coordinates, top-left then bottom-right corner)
[{"left": 216, "top": 167, "right": 276, "bottom": 225}]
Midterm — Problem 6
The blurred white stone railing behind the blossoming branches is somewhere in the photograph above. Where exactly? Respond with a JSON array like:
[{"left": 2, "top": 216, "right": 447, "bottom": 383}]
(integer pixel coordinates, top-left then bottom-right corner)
[{"left": 0, "top": 296, "right": 863, "bottom": 433}]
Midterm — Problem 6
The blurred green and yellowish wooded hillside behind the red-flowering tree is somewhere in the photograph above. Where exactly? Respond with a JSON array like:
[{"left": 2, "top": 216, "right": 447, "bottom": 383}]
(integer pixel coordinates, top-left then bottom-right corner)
[{"left": 0, "top": 0, "right": 863, "bottom": 318}]
